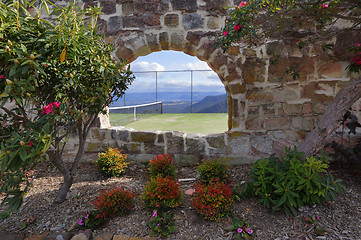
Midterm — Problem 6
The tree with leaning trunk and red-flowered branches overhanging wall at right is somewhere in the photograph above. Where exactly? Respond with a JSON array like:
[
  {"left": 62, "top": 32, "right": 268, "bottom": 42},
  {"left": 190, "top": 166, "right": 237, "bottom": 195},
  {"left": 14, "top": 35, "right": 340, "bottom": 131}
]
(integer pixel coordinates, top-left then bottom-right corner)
[{"left": 219, "top": 0, "right": 361, "bottom": 155}]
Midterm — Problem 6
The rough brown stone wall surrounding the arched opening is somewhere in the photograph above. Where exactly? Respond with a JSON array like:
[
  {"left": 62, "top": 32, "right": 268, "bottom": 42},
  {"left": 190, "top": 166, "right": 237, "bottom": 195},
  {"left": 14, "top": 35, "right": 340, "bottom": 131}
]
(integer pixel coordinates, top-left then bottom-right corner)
[{"left": 54, "top": 0, "right": 361, "bottom": 163}]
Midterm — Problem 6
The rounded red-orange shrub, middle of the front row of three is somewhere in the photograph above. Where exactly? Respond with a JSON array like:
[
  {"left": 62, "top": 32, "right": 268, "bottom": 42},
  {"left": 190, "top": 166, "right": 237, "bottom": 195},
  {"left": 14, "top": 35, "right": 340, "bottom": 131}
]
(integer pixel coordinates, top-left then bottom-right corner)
[{"left": 142, "top": 176, "right": 183, "bottom": 210}]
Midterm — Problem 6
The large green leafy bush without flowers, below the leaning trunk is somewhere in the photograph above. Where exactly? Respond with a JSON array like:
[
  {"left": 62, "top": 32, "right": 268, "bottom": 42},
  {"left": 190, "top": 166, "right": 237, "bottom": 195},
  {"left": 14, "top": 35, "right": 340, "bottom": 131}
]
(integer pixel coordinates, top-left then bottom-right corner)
[{"left": 238, "top": 147, "right": 343, "bottom": 215}]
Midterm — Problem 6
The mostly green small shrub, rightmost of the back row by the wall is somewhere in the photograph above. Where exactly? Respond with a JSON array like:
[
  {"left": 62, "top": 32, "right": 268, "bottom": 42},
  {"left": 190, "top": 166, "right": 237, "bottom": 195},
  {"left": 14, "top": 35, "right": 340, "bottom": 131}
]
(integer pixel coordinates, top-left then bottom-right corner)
[{"left": 197, "top": 159, "right": 228, "bottom": 183}]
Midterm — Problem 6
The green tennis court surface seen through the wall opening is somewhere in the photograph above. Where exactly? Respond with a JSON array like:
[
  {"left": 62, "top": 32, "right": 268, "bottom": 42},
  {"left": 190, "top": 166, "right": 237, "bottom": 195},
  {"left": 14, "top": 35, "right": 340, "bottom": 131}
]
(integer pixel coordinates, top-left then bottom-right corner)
[{"left": 109, "top": 113, "right": 228, "bottom": 134}]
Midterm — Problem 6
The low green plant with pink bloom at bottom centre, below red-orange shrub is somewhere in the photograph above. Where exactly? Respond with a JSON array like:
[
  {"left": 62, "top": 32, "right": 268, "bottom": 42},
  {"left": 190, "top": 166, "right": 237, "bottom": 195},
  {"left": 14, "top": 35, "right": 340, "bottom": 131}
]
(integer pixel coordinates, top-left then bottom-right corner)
[{"left": 147, "top": 210, "right": 177, "bottom": 238}]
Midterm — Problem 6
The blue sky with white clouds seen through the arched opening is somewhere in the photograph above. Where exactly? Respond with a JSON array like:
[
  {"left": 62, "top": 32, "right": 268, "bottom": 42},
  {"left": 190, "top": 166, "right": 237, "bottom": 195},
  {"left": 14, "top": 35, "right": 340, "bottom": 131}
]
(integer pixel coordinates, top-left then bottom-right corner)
[{"left": 127, "top": 51, "right": 225, "bottom": 93}]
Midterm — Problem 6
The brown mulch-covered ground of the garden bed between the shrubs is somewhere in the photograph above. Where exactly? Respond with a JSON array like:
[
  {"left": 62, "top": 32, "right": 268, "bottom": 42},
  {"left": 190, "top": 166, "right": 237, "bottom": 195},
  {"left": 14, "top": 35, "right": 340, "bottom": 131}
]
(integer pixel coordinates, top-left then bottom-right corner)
[{"left": 0, "top": 158, "right": 361, "bottom": 240}]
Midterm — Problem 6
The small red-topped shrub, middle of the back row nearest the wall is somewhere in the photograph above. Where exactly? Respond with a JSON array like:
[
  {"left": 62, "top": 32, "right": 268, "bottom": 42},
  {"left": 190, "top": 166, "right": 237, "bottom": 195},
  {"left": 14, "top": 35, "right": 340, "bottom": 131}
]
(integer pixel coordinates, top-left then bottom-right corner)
[{"left": 149, "top": 154, "right": 177, "bottom": 179}]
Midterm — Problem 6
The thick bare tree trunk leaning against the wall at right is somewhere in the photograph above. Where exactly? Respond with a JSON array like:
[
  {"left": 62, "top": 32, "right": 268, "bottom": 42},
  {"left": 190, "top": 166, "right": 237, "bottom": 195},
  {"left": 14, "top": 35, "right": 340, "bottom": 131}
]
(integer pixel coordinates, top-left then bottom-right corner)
[{"left": 298, "top": 77, "right": 361, "bottom": 156}]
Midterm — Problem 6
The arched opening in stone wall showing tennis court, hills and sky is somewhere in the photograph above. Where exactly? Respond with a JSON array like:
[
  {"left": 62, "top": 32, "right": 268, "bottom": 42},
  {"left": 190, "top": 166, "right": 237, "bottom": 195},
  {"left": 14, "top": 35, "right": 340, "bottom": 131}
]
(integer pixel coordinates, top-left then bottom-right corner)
[{"left": 109, "top": 51, "right": 228, "bottom": 134}]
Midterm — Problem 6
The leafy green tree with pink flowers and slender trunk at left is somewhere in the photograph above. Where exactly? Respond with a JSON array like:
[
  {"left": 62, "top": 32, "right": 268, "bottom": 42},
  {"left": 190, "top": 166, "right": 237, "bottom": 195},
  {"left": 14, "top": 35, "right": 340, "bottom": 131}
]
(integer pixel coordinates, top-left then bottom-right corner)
[{"left": 0, "top": 0, "right": 133, "bottom": 214}]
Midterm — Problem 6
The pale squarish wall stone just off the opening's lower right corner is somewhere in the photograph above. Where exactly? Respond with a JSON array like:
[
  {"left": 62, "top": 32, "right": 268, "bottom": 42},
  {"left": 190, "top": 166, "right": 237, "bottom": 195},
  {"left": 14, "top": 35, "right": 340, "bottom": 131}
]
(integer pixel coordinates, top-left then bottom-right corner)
[{"left": 227, "top": 132, "right": 251, "bottom": 154}]
